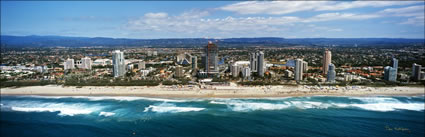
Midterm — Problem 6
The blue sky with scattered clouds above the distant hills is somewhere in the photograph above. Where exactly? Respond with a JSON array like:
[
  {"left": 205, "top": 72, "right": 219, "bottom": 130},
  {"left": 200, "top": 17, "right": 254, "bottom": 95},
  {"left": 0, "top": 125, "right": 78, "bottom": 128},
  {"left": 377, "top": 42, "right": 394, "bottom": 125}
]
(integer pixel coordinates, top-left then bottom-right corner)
[{"left": 1, "top": 1, "right": 425, "bottom": 39}]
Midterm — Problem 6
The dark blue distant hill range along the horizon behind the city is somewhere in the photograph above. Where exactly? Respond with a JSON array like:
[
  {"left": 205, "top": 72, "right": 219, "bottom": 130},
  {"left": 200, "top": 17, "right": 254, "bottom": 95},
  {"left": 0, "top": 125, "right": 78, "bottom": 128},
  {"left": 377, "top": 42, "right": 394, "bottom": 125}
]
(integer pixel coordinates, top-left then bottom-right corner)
[{"left": 1, "top": 35, "right": 425, "bottom": 47}]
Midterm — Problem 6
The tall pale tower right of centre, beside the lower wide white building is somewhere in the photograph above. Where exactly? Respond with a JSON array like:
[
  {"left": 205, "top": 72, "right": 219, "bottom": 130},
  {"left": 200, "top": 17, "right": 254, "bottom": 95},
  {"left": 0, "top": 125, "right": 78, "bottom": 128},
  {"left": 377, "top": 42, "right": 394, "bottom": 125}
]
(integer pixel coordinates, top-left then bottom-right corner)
[{"left": 249, "top": 51, "right": 265, "bottom": 77}]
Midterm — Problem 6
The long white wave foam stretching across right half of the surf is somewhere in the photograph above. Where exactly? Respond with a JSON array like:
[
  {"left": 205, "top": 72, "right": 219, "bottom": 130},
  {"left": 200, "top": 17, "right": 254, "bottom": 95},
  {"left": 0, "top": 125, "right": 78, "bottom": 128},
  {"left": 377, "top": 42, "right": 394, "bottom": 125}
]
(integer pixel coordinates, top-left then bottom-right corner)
[{"left": 210, "top": 97, "right": 425, "bottom": 112}]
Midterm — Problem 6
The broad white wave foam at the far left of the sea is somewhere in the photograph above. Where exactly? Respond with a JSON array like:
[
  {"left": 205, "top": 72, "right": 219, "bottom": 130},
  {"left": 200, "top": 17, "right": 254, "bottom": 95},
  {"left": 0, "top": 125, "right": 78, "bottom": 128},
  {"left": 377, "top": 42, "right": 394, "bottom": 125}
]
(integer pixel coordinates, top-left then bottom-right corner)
[{"left": 2, "top": 101, "right": 102, "bottom": 116}]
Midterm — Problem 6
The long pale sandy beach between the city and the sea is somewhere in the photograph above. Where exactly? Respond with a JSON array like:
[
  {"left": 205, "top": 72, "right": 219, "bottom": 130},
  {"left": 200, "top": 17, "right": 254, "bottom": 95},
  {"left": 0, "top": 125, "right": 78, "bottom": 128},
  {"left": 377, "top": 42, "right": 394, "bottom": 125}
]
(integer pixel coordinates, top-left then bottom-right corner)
[{"left": 1, "top": 85, "right": 425, "bottom": 98}]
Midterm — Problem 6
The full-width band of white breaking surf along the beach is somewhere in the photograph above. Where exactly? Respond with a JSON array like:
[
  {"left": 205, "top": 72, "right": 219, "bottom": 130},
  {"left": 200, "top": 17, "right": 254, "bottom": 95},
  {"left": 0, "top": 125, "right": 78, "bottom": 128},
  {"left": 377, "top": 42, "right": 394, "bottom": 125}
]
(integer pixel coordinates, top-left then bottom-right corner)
[{"left": 0, "top": 96, "right": 425, "bottom": 117}]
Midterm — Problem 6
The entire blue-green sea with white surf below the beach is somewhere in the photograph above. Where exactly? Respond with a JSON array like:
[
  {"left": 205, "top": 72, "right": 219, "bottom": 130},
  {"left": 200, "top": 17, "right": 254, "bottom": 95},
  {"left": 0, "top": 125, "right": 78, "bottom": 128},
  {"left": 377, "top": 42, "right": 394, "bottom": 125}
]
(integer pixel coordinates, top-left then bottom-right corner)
[{"left": 0, "top": 96, "right": 425, "bottom": 137}]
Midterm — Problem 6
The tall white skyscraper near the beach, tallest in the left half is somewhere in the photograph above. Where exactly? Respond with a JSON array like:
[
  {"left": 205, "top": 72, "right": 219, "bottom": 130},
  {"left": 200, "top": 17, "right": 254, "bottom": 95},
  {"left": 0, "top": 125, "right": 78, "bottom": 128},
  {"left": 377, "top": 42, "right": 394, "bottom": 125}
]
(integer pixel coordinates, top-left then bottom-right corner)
[{"left": 112, "top": 50, "right": 125, "bottom": 77}]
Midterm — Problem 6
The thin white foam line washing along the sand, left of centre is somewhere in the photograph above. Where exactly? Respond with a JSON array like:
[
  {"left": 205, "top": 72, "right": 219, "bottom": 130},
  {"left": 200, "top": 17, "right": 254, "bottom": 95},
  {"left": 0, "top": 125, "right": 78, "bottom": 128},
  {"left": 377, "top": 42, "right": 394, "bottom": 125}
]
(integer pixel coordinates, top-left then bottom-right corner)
[{"left": 29, "top": 96, "right": 196, "bottom": 102}]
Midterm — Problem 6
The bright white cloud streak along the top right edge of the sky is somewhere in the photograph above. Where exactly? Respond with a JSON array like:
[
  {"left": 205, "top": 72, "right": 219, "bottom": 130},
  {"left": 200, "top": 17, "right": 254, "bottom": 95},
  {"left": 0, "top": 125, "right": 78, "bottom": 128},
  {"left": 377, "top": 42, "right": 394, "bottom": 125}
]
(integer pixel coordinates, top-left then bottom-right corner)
[{"left": 218, "top": 1, "right": 423, "bottom": 15}]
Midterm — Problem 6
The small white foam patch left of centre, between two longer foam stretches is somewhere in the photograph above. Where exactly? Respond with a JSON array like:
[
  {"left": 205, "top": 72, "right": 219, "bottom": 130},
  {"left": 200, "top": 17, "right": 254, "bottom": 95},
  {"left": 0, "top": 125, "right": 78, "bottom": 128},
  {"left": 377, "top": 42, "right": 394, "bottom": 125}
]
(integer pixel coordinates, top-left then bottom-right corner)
[{"left": 144, "top": 103, "right": 205, "bottom": 113}]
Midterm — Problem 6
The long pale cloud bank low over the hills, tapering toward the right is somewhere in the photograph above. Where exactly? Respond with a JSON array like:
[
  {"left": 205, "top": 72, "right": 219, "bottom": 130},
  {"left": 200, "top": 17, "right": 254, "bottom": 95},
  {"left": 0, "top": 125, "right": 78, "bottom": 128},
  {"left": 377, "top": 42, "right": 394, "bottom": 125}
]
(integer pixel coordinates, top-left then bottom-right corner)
[{"left": 124, "top": 11, "right": 396, "bottom": 36}]
